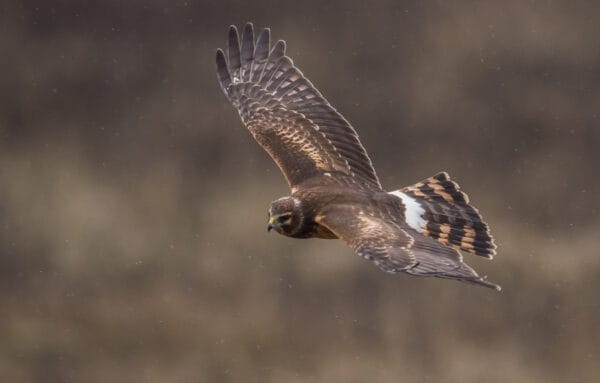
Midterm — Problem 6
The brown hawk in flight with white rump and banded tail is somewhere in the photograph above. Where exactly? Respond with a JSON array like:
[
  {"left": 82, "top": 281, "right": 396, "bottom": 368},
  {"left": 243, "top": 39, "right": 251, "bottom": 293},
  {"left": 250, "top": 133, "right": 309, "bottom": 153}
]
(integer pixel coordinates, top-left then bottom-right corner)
[{"left": 216, "top": 23, "right": 500, "bottom": 290}]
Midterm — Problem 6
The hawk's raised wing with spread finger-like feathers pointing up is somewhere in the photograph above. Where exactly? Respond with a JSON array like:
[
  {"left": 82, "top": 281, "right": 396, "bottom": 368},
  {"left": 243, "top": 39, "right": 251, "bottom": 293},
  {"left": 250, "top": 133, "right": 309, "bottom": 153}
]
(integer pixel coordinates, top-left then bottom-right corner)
[{"left": 217, "top": 23, "right": 381, "bottom": 189}]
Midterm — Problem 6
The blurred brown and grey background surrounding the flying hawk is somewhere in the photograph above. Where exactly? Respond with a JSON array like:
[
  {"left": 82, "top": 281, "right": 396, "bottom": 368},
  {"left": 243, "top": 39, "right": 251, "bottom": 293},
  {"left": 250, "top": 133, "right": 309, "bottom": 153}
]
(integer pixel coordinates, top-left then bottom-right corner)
[{"left": 0, "top": 0, "right": 600, "bottom": 382}]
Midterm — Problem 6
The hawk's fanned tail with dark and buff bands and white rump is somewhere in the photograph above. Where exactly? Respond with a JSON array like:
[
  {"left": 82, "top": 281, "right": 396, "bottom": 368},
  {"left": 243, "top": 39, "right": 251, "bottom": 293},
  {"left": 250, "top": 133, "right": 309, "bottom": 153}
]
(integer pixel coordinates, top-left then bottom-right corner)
[{"left": 391, "top": 172, "right": 496, "bottom": 259}]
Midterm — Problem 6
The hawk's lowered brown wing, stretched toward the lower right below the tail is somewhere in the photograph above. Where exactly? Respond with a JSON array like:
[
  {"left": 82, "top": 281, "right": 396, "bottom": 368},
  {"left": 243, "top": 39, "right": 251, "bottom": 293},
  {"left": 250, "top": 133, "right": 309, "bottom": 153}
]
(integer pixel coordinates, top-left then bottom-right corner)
[{"left": 316, "top": 205, "right": 500, "bottom": 290}]
